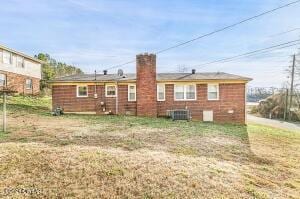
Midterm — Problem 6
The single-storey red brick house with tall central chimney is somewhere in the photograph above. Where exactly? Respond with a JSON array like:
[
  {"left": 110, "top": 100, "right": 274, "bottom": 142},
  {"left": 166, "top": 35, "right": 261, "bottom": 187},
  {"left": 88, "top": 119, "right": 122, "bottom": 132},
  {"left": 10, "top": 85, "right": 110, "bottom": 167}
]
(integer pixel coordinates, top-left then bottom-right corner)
[{"left": 51, "top": 54, "right": 251, "bottom": 124}]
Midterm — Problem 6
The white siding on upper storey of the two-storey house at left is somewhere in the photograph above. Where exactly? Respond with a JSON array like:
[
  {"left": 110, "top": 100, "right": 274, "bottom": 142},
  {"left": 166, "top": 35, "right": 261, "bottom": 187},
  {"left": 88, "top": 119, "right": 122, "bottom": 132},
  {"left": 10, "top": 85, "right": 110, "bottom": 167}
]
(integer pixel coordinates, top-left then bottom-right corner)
[{"left": 0, "top": 49, "right": 41, "bottom": 79}]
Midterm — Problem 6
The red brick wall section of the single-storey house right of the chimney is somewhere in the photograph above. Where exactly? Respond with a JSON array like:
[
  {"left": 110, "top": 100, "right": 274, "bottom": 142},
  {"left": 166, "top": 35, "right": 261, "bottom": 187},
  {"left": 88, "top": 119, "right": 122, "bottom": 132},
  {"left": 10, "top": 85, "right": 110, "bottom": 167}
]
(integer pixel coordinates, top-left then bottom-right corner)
[{"left": 157, "top": 84, "right": 245, "bottom": 124}]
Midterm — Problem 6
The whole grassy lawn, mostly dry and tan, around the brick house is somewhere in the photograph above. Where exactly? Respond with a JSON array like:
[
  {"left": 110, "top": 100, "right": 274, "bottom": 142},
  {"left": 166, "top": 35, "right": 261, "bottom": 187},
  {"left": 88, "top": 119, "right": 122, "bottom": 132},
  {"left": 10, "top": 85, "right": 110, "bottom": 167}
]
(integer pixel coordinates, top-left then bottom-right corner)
[{"left": 0, "top": 97, "right": 300, "bottom": 198}]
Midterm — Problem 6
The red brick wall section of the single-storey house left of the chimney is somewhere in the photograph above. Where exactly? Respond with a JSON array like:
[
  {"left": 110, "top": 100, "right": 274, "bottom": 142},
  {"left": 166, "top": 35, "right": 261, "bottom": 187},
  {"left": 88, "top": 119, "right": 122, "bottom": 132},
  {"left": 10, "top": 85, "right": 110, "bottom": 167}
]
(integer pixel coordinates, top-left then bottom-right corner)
[{"left": 52, "top": 85, "right": 136, "bottom": 115}]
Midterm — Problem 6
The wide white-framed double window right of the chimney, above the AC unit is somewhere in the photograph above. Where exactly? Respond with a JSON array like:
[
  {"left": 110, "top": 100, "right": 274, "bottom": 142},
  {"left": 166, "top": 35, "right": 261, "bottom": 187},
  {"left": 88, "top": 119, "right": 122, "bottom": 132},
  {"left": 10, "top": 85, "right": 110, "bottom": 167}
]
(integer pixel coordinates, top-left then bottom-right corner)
[{"left": 174, "top": 84, "right": 196, "bottom": 100}]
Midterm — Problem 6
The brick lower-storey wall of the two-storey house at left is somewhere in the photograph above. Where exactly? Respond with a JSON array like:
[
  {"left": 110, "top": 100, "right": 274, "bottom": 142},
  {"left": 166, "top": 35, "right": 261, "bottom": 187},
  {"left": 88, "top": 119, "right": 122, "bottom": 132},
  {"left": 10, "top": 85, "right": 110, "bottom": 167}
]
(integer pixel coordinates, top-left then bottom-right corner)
[{"left": 0, "top": 70, "right": 40, "bottom": 95}]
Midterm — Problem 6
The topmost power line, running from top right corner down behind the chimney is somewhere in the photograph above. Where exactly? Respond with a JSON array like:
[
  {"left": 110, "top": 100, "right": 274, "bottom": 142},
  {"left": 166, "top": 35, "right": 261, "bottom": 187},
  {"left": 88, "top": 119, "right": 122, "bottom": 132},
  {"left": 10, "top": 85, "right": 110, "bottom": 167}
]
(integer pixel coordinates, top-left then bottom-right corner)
[{"left": 105, "top": 0, "right": 300, "bottom": 70}]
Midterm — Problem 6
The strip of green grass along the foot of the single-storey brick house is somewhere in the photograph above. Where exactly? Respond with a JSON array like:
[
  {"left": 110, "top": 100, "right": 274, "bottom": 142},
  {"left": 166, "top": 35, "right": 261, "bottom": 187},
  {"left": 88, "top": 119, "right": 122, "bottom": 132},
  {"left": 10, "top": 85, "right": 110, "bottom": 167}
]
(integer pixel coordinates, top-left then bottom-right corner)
[{"left": 63, "top": 112, "right": 247, "bottom": 139}]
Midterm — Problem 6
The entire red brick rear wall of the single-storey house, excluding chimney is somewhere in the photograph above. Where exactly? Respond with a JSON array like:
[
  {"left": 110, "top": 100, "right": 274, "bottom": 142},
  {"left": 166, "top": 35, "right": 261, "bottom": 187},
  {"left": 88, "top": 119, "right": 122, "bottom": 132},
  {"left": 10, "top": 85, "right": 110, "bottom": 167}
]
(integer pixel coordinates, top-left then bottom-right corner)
[{"left": 52, "top": 83, "right": 245, "bottom": 124}]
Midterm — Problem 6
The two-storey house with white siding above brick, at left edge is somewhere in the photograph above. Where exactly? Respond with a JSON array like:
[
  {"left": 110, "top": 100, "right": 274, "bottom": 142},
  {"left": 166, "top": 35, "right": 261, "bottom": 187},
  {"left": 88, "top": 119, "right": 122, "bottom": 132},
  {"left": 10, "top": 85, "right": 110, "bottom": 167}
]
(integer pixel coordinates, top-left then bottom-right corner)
[{"left": 0, "top": 45, "right": 42, "bottom": 95}]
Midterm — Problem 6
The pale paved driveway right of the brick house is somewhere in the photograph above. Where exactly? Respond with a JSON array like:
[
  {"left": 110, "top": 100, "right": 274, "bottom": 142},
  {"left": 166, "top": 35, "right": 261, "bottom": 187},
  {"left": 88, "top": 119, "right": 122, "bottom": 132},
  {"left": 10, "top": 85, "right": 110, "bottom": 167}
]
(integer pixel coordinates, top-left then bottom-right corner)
[{"left": 247, "top": 114, "right": 300, "bottom": 133}]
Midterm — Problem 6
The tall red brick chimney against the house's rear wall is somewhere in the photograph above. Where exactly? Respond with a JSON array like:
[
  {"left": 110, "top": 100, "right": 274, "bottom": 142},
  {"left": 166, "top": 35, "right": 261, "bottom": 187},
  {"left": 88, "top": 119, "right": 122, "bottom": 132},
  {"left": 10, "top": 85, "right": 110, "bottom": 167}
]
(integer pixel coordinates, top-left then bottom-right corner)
[{"left": 136, "top": 53, "right": 157, "bottom": 117}]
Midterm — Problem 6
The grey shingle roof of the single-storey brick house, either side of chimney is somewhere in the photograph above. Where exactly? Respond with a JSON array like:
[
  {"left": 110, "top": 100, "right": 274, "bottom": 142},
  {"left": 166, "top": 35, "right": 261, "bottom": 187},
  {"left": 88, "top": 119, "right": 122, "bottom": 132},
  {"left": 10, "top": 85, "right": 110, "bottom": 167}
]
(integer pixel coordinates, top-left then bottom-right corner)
[{"left": 50, "top": 72, "right": 252, "bottom": 82}]
